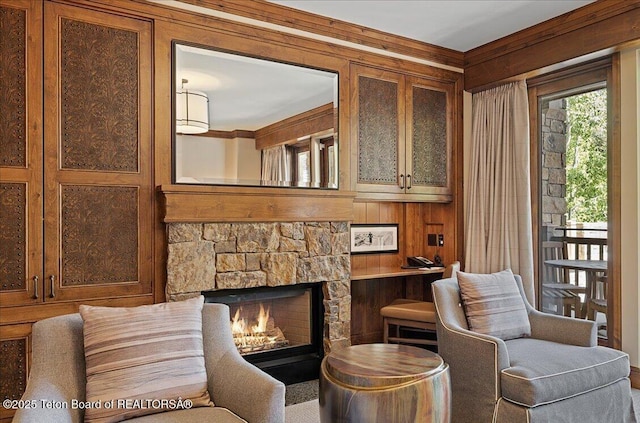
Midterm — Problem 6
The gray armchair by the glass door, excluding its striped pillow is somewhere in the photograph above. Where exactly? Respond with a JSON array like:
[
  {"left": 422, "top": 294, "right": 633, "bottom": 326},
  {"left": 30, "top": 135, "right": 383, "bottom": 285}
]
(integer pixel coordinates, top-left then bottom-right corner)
[{"left": 432, "top": 275, "right": 636, "bottom": 423}]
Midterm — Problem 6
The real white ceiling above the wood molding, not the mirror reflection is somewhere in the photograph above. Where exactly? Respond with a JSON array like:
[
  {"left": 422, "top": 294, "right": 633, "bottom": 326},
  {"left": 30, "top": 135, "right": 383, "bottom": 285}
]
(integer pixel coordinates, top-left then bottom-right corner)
[{"left": 269, "top": 0, "right": 593, "bottom": 52}]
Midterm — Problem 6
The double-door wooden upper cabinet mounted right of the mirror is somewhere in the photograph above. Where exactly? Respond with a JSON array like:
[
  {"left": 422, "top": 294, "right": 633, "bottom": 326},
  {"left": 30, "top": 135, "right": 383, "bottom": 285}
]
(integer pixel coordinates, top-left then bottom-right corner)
[{"left": 351, "top": 65, "right": 455, "bottom": 202}]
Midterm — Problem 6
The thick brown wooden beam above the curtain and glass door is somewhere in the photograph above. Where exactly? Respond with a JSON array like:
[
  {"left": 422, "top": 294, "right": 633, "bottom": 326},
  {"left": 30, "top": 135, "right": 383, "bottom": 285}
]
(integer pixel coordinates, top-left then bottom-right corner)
[{"left": 464, "top": 0, "right": 640, "bottom": 92}]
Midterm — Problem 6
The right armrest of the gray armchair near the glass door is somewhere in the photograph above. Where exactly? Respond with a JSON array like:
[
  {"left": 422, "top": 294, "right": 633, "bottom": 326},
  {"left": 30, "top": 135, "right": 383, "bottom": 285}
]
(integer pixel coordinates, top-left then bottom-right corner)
[{"left": 529, "top": 310, "right": 598, "bottom": 347}]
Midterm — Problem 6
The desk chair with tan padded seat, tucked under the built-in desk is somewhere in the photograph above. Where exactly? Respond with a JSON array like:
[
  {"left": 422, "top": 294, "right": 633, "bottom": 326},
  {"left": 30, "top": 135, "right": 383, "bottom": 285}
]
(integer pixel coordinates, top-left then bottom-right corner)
[{"left": 380, "top": 261, "right": 460, "bottom": 345}]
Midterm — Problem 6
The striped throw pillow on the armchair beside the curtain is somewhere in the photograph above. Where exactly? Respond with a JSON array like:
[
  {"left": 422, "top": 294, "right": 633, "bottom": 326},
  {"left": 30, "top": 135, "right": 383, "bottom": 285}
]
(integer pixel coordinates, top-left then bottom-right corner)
[{"left": 457, "top": 269, "right": 531, "bottom": 340}]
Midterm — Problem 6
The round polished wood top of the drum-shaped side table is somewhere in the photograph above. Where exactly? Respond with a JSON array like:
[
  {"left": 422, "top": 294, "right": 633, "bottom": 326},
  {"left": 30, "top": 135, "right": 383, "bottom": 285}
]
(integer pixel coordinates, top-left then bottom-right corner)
[{"left": 325, "top": 344, "right": 446, "bottom": 387}]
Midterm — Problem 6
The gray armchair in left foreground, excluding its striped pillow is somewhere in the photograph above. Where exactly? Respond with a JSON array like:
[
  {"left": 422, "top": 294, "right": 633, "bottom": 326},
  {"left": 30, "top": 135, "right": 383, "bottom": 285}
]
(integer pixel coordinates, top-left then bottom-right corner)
[{"left": 13, "top": 304, "right": 285, "bottom": 423}]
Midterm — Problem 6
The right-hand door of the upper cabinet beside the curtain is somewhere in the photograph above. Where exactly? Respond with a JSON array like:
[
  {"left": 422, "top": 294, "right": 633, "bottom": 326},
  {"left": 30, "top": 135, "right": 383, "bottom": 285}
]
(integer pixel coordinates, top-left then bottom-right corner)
[{"left": 406, "top": 77, "right": 455, "bottom": 201}]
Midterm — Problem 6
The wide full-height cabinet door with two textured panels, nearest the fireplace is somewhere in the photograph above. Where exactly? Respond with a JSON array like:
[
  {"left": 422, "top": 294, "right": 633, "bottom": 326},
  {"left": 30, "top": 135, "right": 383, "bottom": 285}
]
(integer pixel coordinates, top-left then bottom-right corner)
[{"left": 44, "top": 3, "right": 153, "bottom": 301}]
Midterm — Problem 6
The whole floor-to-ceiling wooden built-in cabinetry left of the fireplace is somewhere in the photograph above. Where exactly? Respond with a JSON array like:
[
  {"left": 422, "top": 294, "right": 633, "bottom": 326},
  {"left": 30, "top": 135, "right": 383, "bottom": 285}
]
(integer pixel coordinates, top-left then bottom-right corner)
[{"left": 0, "top": 0, "right": 154, "bottom": 417}]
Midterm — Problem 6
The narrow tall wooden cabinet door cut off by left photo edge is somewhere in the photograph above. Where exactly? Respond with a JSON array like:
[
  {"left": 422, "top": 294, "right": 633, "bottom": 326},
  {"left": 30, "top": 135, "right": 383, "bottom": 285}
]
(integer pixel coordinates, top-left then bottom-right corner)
[{"left": 0, "top": 0, "right": 42, "bottom": 307}]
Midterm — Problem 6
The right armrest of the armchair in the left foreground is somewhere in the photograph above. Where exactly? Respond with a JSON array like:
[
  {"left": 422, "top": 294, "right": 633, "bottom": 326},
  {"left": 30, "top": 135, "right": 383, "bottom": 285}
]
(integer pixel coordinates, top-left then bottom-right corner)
[{"left": 208, "top": 350, "right": 285, "bottom": 423}]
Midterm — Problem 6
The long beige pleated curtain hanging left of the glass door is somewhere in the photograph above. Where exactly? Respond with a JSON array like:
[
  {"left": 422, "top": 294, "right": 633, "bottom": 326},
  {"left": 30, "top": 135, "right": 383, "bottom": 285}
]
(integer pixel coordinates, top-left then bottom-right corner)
[{"left": 465, "top": 81, "right": 535, "bottom": 304}]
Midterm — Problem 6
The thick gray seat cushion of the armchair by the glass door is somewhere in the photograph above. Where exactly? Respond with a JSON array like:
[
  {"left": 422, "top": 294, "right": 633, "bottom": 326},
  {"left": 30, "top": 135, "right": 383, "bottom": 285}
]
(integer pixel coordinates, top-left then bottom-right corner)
[{"left": 500, "top": 338, "right": 629, "bottom": 407}]
